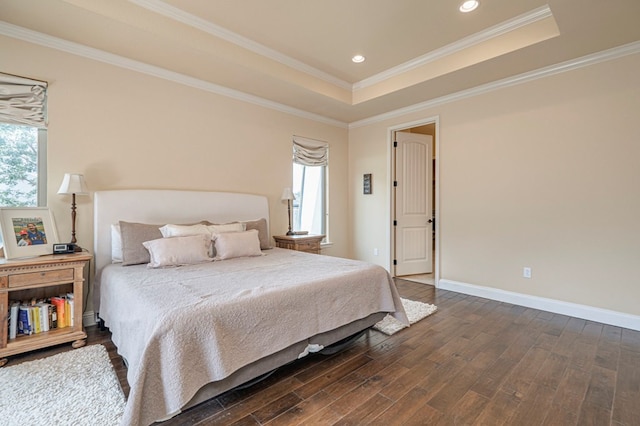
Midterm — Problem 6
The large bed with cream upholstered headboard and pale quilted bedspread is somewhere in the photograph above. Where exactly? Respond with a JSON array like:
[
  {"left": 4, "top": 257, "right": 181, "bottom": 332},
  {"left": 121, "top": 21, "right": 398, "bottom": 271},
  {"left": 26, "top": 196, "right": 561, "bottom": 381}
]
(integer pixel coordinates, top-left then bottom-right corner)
[{"left": 94, "top": 190, "right": 408, "bottom": 425}]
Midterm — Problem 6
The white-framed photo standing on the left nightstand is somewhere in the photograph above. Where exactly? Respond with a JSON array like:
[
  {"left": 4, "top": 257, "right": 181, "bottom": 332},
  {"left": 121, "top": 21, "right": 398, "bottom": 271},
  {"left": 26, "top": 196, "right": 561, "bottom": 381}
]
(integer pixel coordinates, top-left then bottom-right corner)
[{"left": 0, "top": 207, "right": 59, "bottom": 259}]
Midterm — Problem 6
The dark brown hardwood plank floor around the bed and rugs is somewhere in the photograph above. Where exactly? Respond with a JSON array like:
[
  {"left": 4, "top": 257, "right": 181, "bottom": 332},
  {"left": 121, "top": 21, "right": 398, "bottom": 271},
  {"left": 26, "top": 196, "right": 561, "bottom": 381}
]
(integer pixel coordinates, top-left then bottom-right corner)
[{"left": 10, "top": 280, "right": 640, "bottom": 426}]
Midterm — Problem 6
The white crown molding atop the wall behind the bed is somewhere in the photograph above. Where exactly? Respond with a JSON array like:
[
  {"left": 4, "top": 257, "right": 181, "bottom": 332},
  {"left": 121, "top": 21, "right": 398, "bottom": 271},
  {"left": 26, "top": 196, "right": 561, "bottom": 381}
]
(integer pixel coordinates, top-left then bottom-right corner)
[{"left": 0, "top": 21, "right": 348, "bottom": 128}]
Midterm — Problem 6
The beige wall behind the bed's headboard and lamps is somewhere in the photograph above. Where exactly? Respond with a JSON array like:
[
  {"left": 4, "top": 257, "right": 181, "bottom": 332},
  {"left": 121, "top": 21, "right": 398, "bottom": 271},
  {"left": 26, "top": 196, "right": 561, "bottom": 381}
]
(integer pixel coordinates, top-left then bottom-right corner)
[{"left": 0, "top": 37, "right": 348, "bottom": 309}]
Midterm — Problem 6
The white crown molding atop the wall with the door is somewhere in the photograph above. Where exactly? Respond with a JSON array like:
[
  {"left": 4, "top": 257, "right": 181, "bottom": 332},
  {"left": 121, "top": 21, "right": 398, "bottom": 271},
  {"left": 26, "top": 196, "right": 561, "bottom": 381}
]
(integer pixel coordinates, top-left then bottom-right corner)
[{"left": 349, "top": 41, "right": 640, "bottom": 129}]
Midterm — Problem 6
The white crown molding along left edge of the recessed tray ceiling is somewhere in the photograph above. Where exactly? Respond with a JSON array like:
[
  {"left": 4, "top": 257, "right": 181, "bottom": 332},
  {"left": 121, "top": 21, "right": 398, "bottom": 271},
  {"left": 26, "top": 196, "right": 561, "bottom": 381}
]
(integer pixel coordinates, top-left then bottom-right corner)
[{"left": 129, "top": 0, "right": 352, "bottom": 91}]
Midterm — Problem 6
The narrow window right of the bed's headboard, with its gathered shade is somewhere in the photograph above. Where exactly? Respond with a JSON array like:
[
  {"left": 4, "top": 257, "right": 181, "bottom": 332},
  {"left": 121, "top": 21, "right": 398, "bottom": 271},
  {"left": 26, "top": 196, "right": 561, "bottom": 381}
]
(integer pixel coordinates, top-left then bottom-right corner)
[{"left": 292, "top": 136, "right": 329, "bottom": 235}]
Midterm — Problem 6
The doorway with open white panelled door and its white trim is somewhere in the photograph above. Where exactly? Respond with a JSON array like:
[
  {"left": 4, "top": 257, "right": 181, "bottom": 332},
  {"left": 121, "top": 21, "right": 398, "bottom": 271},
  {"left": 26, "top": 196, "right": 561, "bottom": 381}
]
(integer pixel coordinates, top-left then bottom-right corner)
[{"left": 389, "top": 117, "right": 439, "bottom": 285}]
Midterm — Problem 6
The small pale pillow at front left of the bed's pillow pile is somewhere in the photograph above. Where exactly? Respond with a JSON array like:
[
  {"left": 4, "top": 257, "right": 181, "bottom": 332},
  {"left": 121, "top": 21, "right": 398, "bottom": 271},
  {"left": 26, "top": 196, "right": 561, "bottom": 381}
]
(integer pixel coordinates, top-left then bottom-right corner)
[{"left": 142, "top": 234, "right": 213, "bottom": 268}]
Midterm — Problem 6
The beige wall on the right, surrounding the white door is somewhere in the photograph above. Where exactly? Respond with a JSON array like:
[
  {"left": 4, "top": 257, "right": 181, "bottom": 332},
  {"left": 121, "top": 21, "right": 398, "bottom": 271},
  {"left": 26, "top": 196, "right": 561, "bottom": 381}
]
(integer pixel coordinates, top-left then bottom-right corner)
[{"left": 349, "top": 51, "right": 640, "bottom": 315}]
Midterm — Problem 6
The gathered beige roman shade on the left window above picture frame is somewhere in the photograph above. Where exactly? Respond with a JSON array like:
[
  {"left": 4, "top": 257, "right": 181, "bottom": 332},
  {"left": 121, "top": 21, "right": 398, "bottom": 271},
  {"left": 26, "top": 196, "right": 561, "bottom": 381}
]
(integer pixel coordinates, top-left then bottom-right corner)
[{"left": 0, "top": 73, "right": 47, "bottom": 129}]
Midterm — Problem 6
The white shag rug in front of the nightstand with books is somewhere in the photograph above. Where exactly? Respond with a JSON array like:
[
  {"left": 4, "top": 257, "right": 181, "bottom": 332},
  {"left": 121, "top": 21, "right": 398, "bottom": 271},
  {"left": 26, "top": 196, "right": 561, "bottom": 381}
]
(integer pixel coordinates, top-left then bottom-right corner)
[{"left": 0, "top": 345, "right": 125, "bottom": 426}]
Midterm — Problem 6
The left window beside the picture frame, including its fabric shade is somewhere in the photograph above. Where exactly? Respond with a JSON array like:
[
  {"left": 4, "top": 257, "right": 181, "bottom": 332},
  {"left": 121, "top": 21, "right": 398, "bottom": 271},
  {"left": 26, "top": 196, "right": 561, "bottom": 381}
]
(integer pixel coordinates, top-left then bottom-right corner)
[{"left": 0, "top": 73, "right": 47, "bottom": 207}]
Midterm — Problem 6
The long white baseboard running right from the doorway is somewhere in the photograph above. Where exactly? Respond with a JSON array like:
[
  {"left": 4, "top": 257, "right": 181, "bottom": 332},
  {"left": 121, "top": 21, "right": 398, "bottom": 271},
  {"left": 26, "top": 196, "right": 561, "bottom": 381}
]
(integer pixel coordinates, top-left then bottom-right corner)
[{"left": 437, "top": 279, "right": 640, "bottom": 331}]
